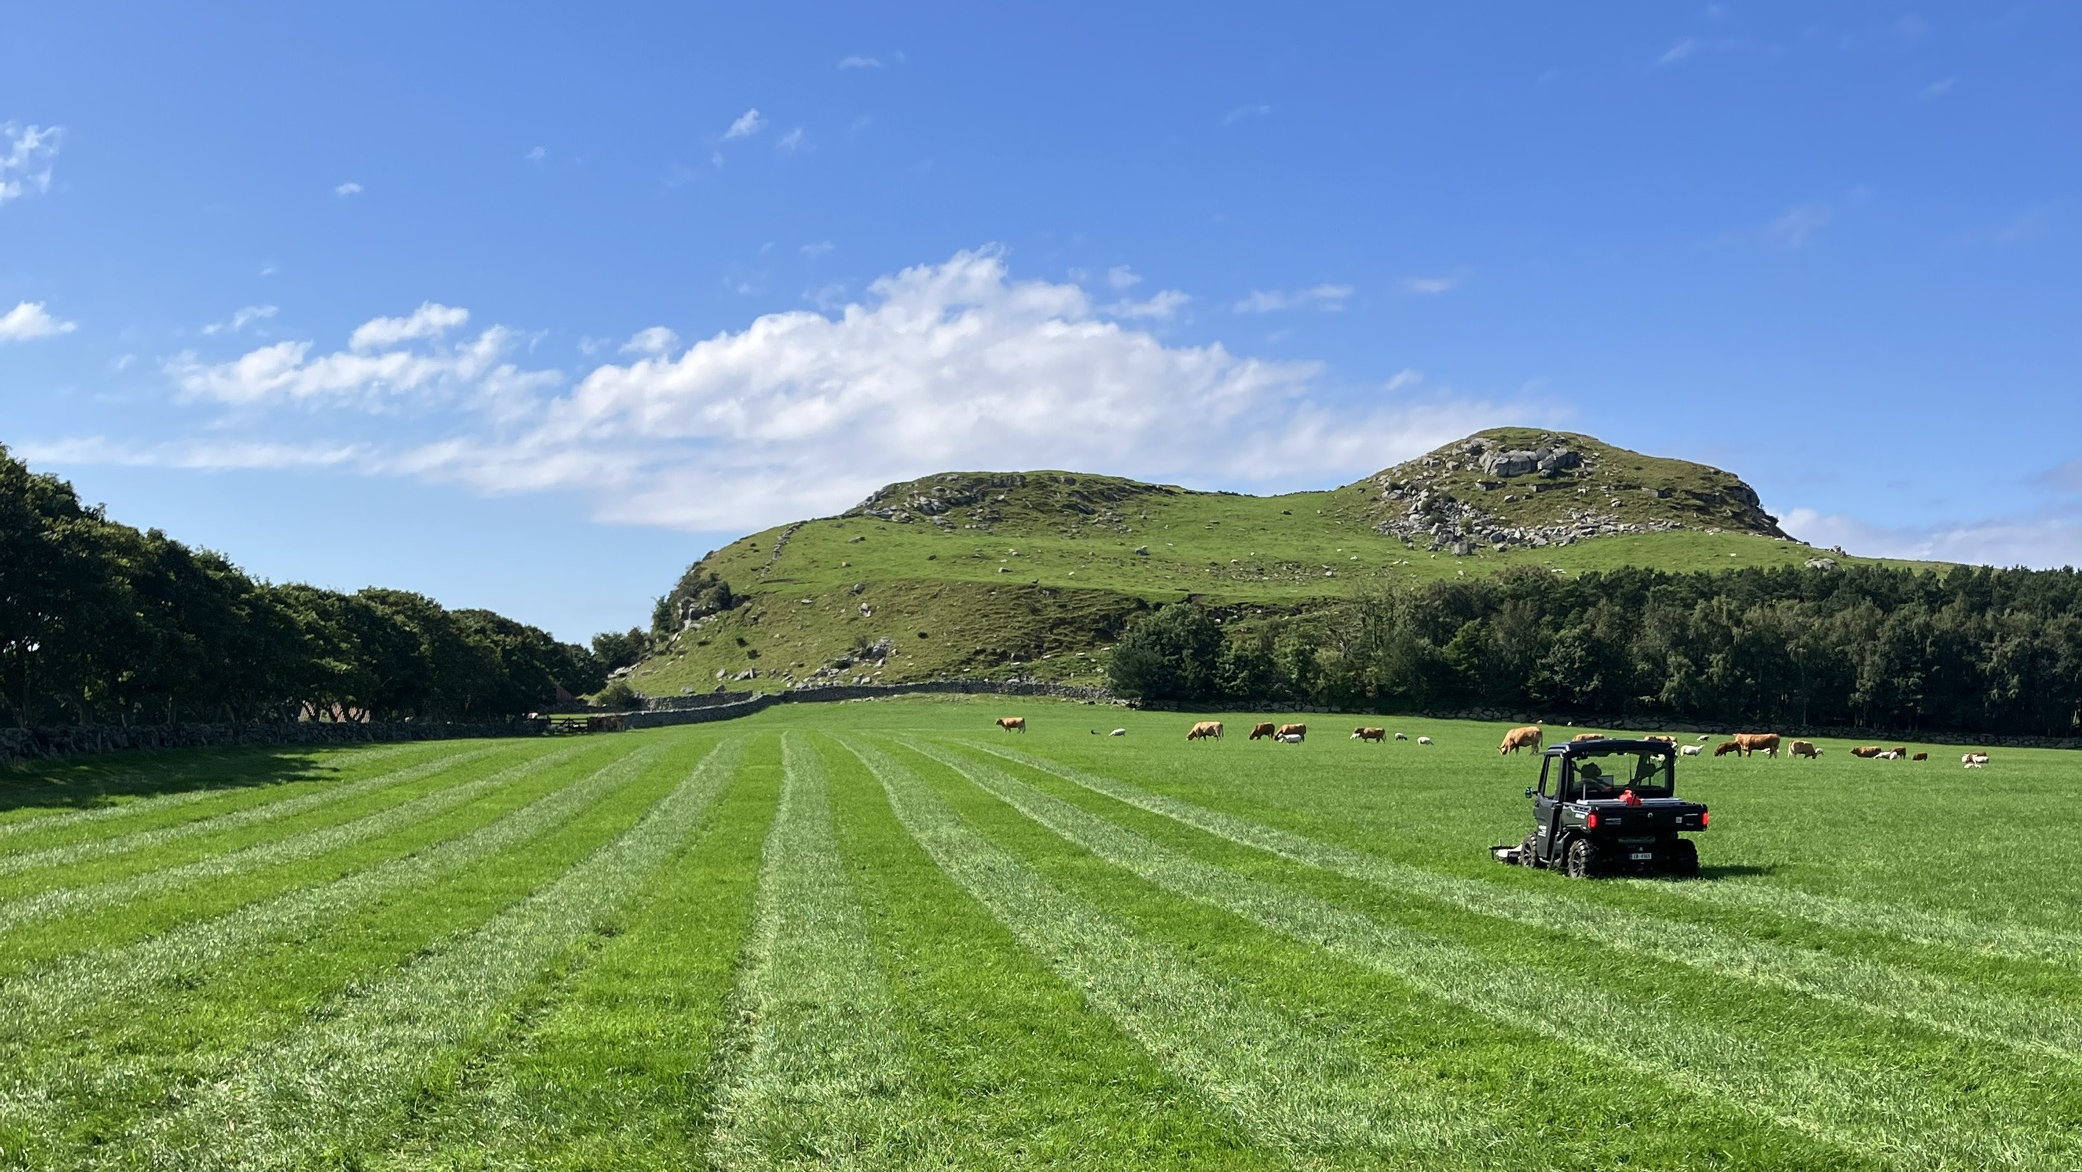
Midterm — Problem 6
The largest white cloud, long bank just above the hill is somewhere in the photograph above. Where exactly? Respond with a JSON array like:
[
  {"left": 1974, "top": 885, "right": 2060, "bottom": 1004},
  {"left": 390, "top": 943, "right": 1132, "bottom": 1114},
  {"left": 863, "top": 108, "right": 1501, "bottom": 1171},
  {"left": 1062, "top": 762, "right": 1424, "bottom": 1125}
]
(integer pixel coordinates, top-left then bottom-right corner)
[{"left": 75, "top": 257, "right": 1545, "bottom": 529}]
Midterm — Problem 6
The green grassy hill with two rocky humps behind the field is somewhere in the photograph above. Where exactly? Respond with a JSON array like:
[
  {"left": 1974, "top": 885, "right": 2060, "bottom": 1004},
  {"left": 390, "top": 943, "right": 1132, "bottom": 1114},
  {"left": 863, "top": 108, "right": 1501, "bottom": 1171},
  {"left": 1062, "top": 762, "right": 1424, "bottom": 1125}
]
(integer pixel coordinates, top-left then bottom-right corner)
[{"left": 631, "top": 429, "right": 1915, "bottom": 695}]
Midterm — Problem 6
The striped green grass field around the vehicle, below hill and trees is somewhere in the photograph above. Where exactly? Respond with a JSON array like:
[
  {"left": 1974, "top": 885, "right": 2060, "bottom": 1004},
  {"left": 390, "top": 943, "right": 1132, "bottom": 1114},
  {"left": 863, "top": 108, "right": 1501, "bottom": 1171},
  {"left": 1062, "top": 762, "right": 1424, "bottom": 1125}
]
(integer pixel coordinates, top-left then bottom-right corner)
[{"left": 0, "top": 699, "right": 2082, "bottom": 1172}]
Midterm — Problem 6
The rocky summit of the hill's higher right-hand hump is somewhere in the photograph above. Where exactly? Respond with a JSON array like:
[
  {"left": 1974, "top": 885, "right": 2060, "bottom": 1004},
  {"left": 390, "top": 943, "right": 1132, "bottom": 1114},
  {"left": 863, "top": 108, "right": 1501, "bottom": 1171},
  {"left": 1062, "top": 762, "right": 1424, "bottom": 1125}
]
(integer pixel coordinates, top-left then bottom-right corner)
[{"left": 1355, "top": 429, "right": 1784, "bottom": 556}]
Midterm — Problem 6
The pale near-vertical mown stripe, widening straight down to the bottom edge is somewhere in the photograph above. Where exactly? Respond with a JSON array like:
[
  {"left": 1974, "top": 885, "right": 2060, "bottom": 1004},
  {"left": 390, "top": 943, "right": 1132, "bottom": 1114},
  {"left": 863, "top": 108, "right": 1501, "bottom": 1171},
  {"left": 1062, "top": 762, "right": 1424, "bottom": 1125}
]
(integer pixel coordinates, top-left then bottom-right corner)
[{"left": 708, "top": 733, "right": 920, "bottom": 1168}]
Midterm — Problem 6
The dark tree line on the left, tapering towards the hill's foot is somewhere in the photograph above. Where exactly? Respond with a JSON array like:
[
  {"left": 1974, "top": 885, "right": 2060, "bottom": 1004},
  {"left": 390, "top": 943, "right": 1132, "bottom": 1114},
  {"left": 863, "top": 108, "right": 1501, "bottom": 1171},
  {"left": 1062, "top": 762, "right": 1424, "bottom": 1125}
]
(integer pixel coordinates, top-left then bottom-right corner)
[{"left": 0, "top": 445, "right": 624, "bottom": 727}]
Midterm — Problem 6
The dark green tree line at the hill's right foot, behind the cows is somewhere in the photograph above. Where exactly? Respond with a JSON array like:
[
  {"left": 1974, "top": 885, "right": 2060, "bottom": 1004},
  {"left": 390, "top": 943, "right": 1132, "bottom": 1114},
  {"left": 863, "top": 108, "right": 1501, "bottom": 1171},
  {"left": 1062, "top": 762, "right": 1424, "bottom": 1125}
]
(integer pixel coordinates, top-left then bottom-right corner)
[{"left": 1110, "top": 564, "right": 2082, "bottom": 737}]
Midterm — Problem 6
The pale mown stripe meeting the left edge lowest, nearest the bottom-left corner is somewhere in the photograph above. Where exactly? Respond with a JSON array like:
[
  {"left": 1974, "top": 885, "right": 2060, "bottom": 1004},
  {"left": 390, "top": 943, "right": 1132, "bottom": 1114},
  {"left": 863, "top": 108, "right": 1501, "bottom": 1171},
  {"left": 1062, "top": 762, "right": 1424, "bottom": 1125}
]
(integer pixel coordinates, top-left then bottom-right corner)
[{"left": 0, "top": 736, "right": 666, "bottom": 1043}]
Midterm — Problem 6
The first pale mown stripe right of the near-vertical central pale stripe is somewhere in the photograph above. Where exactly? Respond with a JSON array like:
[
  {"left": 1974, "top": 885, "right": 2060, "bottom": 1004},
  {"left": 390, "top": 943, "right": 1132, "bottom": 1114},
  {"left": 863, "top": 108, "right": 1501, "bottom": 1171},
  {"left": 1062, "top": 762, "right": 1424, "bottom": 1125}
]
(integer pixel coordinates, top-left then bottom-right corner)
[{"left": 845, "top": 741, "right": 1501, "bottom": 1166}]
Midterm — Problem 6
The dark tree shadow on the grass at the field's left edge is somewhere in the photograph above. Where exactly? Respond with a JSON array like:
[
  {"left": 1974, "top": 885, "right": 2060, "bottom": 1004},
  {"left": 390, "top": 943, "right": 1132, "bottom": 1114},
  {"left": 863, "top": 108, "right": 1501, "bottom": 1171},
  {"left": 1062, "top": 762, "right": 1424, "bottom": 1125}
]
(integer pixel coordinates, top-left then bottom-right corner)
[{"left": 0, "top": 745, "right": 368, "bottom": 816}]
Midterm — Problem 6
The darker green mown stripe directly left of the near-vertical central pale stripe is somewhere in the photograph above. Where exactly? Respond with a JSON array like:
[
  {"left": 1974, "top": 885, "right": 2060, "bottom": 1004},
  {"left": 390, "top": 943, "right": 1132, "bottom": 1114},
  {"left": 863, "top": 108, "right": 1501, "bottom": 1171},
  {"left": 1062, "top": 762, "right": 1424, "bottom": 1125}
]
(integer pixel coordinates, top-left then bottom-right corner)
[{"left": 369, "top": 737, "right": 781, "bottom": 1172}]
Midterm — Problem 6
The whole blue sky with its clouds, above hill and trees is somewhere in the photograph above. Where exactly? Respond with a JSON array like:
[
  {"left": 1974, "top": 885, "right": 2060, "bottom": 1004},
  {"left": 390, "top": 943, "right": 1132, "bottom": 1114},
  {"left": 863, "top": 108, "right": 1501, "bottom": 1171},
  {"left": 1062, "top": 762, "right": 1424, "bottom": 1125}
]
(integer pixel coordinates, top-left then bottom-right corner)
[{"left": 0, "top": 2, "right": 2082, "bottom": 639}]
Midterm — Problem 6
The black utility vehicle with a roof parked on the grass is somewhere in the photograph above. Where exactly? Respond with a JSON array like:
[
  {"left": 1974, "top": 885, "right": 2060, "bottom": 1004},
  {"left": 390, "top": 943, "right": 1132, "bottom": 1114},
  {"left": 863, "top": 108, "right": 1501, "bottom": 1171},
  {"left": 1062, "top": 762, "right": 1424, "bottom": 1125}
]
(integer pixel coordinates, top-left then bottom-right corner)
[{"left": 1489, "top": 739, "right": 1707, "bottom": 878}]
